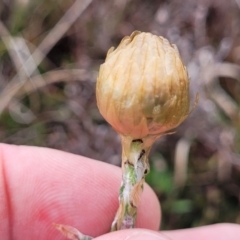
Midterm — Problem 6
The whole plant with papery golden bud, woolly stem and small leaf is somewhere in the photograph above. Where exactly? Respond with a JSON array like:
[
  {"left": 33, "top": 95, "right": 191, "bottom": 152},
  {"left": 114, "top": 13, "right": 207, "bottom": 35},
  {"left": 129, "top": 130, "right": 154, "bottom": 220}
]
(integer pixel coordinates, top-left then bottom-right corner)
[{"left": 57, "top": 31, "right": 194, "bottom": 240}]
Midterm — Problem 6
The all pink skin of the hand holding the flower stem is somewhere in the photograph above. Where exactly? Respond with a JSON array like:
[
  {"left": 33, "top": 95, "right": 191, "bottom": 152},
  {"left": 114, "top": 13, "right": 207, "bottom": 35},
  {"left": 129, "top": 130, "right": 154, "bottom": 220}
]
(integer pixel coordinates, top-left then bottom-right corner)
[{"left": 0, "top": 144, "right": 240, "bottom": 240}]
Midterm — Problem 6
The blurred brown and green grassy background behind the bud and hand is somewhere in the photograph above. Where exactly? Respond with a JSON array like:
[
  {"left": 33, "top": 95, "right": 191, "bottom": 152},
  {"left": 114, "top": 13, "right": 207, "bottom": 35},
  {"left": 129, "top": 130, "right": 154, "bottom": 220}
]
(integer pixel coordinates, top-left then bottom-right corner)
[{"left": 0, "top": 0, "right": 240, "bottom": 229}]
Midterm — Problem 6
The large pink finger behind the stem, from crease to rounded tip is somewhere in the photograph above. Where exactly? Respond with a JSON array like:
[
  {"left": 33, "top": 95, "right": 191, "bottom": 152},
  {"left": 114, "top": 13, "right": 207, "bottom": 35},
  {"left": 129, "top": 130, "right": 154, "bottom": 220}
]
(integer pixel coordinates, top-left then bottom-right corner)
[{"left": 0, "top": 144, "right": 160, "bottom": 240}]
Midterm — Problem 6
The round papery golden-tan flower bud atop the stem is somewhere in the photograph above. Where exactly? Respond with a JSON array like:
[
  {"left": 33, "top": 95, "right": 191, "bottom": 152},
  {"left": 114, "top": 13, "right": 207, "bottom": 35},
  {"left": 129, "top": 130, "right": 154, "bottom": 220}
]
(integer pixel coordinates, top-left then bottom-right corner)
[{"left": 96, "top": 31, "right": 189, "bottom": 139}]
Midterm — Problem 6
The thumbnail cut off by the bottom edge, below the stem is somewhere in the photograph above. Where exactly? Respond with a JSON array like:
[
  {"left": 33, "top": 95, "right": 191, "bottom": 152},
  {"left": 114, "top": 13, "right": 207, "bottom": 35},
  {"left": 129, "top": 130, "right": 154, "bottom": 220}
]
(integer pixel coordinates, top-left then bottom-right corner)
[{"left": 124, "top": 231, "right": 171, "bottom": 240}]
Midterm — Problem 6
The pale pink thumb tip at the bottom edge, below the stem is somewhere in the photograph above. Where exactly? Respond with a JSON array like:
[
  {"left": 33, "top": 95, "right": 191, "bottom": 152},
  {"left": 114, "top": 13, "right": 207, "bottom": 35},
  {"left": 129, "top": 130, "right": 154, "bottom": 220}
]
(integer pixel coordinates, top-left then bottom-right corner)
[{"left": 94, "top": 228, "right": 171, "bottom": 240}]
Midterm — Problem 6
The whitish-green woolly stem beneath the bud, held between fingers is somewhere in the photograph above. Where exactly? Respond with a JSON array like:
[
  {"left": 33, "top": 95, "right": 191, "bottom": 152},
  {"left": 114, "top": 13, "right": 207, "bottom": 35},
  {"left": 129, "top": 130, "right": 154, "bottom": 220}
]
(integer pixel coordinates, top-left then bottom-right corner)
[{"left": 111, "top": 136, "right": 155, "bottom": 231}]
